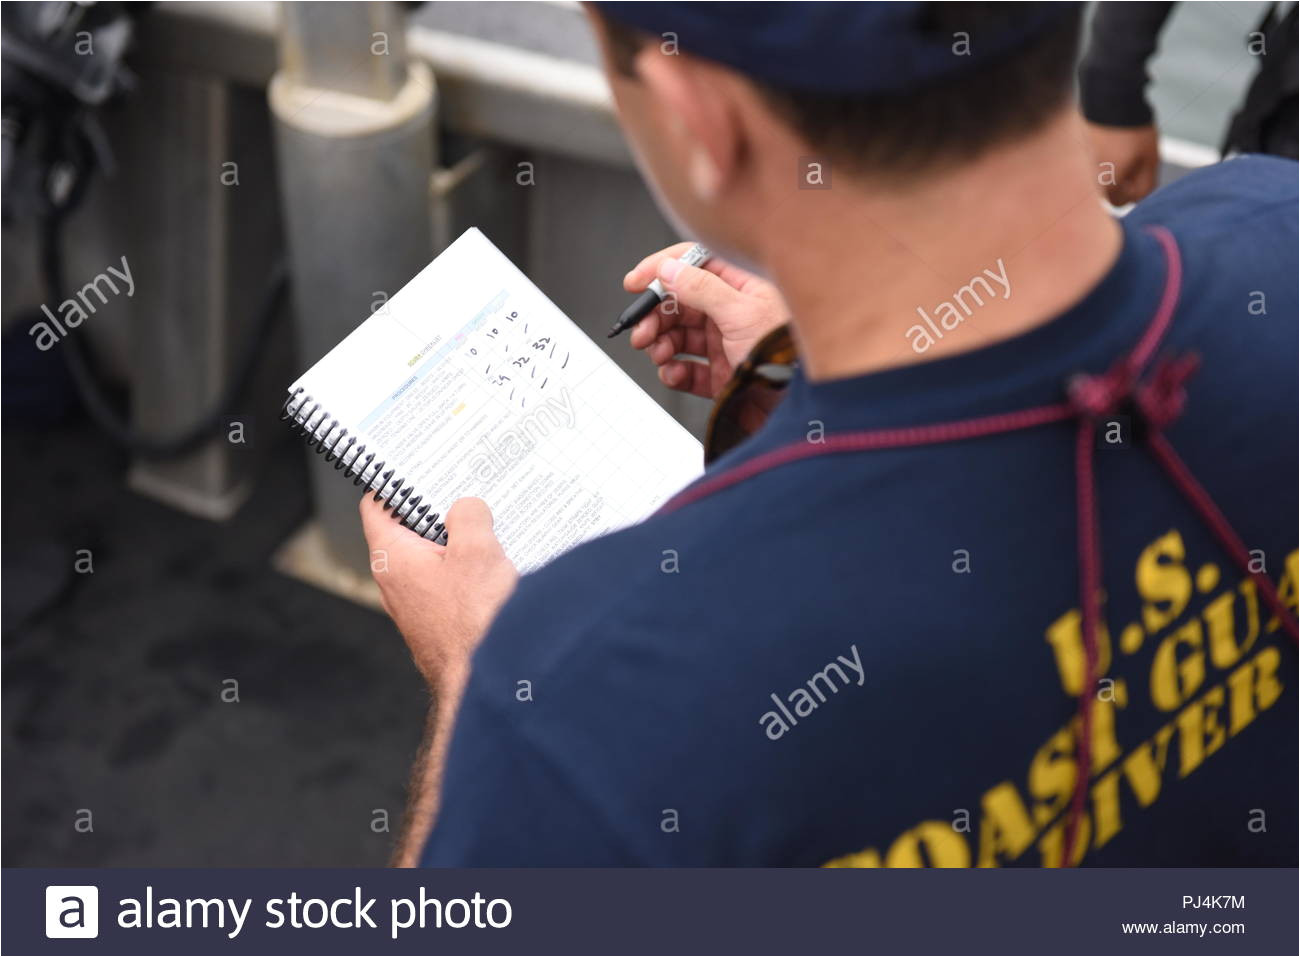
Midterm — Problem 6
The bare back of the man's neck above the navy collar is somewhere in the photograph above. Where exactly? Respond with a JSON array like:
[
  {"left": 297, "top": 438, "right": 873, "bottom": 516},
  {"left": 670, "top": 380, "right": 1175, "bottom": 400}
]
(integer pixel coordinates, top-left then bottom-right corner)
[{"left": 755, "top": 111, "right": 1122, "bottom": 380}]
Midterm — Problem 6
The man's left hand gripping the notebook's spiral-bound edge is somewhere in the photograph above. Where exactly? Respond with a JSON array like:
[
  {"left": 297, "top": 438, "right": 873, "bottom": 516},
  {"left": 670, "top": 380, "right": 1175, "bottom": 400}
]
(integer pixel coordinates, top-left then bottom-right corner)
[{"left": 361, "top": 495, "right": 519, "bottom": 696}]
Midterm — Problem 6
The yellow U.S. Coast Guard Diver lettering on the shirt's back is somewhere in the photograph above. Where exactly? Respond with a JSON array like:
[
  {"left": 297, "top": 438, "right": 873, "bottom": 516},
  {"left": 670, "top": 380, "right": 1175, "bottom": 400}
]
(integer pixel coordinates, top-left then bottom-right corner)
[{"left": 826, "top": 548, "right": 1300, "bottom": 867}]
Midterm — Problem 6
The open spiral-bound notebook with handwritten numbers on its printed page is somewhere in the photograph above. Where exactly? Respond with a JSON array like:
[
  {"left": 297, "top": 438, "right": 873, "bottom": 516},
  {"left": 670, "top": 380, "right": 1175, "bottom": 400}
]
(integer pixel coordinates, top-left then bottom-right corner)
[{"left": 282, "top": 229, "right": 702, "bottom": 572}]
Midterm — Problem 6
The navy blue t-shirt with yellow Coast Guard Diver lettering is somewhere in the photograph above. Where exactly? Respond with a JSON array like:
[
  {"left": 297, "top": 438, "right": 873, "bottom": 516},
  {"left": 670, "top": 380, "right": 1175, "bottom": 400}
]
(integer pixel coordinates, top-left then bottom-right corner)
[{"left": 424, "top": 157, "right": 1297, "bottom": 866}]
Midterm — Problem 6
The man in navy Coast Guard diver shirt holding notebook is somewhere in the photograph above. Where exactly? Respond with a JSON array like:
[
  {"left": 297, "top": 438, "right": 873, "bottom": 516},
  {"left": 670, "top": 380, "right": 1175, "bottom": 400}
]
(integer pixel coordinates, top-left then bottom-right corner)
[{"left": 363, "top": 3, "right": 1297, "bottom": 866}]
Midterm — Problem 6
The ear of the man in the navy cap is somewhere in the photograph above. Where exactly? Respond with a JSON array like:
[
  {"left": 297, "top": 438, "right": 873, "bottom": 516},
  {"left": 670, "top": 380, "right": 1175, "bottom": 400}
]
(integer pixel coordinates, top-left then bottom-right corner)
[{"left": 636, "top": 43, "right": 744, "bottom": 202}]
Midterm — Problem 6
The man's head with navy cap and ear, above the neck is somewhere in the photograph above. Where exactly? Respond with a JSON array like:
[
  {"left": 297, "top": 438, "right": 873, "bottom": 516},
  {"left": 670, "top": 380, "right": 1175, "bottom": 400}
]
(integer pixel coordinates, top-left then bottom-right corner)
[{"left": 588, "top": 3, "right": 1079, "bottom": 265}]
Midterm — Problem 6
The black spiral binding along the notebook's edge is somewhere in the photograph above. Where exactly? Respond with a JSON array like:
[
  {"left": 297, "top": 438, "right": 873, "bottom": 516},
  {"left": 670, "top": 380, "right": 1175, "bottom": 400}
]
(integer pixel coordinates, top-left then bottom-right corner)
[{"left": 280, "top": 386, "right": 447, "bottom": 545}]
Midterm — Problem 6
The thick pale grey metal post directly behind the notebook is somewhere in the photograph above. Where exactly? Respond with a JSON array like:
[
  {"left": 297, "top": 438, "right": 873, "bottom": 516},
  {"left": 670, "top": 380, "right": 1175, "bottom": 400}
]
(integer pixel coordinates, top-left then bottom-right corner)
[{"left": 269, "top": 3, "right": 436, "bottom": 572}]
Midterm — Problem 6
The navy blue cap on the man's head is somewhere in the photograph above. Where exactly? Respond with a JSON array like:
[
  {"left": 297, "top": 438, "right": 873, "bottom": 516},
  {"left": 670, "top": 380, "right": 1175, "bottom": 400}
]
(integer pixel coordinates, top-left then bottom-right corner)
[{"left": 594, "top": 3, "right": 1082, "bottom": 94}]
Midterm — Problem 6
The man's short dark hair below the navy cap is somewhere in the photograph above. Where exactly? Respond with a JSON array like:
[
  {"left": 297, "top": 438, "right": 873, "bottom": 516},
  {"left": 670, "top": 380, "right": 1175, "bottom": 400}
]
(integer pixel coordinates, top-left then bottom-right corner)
[{"left": 601, "top": 3, "right": 1080, "bottom": 178}]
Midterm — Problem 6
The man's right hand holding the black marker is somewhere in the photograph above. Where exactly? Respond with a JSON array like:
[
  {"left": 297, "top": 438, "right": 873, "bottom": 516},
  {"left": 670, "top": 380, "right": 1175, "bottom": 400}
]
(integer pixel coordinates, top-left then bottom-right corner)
[{"left": 623, "top": 243, "right": 790, "bottom": 399}]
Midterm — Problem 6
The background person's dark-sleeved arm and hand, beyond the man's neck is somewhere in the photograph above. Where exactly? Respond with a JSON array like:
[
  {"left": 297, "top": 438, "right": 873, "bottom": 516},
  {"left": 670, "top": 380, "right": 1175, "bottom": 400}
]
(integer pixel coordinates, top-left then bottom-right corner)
[{"left": 1079, "top": 3, "right": 1174, "bottom": 205}]
